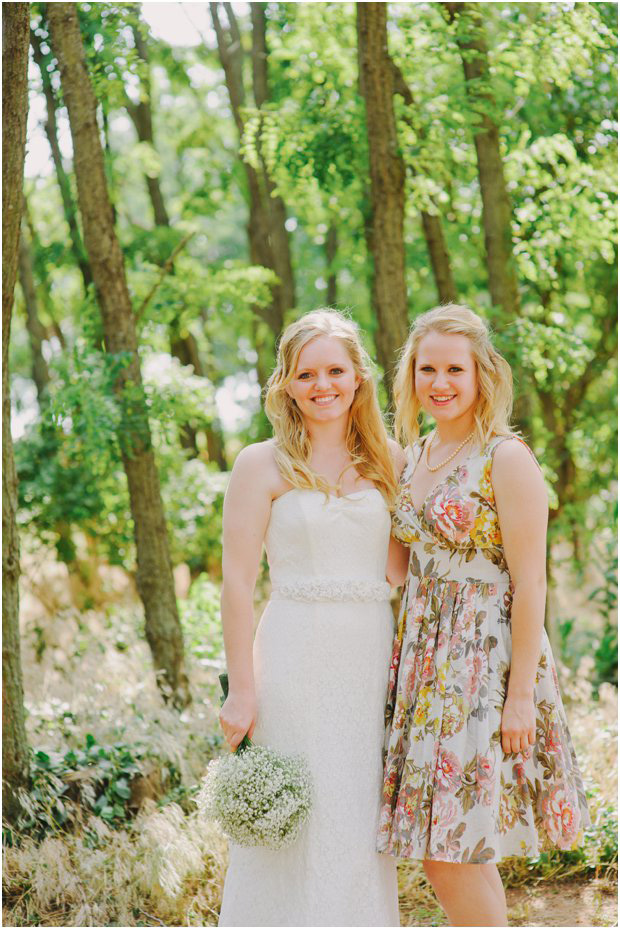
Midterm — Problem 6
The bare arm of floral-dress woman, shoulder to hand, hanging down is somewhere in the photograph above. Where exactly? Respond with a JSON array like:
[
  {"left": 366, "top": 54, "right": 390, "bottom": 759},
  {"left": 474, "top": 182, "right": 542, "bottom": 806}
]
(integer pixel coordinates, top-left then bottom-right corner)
[{"left": 491, "top": 440, "right": 549, "bottom": 752}]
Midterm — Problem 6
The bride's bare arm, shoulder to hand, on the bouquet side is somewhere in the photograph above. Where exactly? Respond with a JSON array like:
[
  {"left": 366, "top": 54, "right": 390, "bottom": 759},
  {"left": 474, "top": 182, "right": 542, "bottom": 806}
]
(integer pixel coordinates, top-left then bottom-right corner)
[{"left": 220, "top": 444, "right": 275, "bottom": 749}]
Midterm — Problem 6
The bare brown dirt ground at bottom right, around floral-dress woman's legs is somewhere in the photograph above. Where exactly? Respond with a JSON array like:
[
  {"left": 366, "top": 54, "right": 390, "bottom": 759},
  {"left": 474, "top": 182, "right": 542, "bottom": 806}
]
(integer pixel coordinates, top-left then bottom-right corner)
[{"left": 401, "top": 880, "right": 618, "bottom": 926}]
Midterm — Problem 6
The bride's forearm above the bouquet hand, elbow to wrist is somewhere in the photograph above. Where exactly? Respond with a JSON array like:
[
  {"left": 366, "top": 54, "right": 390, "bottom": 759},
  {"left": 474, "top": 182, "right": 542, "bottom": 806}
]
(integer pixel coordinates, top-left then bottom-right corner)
[{"left": 222, "top": 582, "right": 254, "bottom": 694}]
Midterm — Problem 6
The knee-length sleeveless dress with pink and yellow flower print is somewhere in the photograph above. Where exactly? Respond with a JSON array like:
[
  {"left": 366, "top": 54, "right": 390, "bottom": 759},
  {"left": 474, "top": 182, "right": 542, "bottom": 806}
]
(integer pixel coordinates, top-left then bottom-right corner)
[{"left": 377, "top": 436, "right": 589, "bottom": 864}]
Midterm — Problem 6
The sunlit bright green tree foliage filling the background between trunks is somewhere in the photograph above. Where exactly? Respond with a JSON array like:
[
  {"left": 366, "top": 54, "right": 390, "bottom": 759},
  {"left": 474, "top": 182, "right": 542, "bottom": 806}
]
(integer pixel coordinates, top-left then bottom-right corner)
[{"left": 11, "top": 3, "right": 617, "bottom": 681}]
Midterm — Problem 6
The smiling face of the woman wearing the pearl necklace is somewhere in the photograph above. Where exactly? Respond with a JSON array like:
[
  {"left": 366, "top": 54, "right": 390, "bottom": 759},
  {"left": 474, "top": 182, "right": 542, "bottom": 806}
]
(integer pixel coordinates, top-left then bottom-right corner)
[{"left": 415, "top": 332, "right": 478, "bottom": 423}]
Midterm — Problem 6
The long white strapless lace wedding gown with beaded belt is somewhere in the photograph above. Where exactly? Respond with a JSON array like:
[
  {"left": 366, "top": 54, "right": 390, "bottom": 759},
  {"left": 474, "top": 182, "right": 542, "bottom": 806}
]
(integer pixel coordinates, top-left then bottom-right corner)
[{"left": 219, "top": 488, "right": 400, "bottom": 926}]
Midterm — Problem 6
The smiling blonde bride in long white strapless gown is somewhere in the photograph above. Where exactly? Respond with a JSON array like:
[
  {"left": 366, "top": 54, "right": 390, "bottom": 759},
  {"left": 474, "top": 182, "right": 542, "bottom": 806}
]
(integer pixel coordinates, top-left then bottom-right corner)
[{"left": 219, "top": 310, "right": 406, "bottom": 926}]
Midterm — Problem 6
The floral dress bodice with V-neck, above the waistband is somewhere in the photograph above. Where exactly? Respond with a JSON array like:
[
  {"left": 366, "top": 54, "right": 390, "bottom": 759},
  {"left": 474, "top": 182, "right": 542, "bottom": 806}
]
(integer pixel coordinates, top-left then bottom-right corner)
[{"left": 392, "top": 436, "right": 525, "bottom": 583}]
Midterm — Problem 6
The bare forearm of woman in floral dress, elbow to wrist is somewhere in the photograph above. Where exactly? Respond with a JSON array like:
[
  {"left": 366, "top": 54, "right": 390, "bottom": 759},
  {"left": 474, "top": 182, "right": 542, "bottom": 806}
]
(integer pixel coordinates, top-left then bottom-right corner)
[{"left": 508, "top": 578, "right": 546, "bottom": 696}]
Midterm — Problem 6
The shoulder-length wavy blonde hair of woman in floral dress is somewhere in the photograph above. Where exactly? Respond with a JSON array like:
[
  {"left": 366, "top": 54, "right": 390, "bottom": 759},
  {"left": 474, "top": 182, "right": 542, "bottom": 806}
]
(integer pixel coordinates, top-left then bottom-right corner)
[{"left": 394, "top": 303, "right": 513, "bottom": 446}]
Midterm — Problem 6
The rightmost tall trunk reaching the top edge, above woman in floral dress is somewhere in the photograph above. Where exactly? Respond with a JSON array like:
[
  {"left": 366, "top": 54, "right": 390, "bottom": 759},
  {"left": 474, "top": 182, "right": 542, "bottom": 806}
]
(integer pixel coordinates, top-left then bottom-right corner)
[{"left": 443, "top": 3, "right": 521, "bottom": 320}]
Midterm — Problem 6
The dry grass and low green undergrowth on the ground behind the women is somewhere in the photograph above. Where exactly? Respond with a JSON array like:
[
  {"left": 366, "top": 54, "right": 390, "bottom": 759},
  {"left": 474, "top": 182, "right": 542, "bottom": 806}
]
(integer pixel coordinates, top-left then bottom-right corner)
[{"left": 4, "top": 581, "right": 617, "bottom": 926}]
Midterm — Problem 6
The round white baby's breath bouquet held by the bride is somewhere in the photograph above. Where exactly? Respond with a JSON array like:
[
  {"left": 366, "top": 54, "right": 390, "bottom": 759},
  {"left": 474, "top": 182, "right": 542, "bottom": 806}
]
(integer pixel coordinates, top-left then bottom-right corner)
[{"left": 196, "top": 675, "right": 312, "bottom": 849}]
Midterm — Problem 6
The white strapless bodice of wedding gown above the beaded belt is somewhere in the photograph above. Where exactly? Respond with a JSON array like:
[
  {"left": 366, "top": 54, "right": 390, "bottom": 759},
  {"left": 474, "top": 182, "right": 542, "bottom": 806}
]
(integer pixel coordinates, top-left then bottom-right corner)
[{"left": 265, "top": 488, "right": 390, "bottom": 587}]
